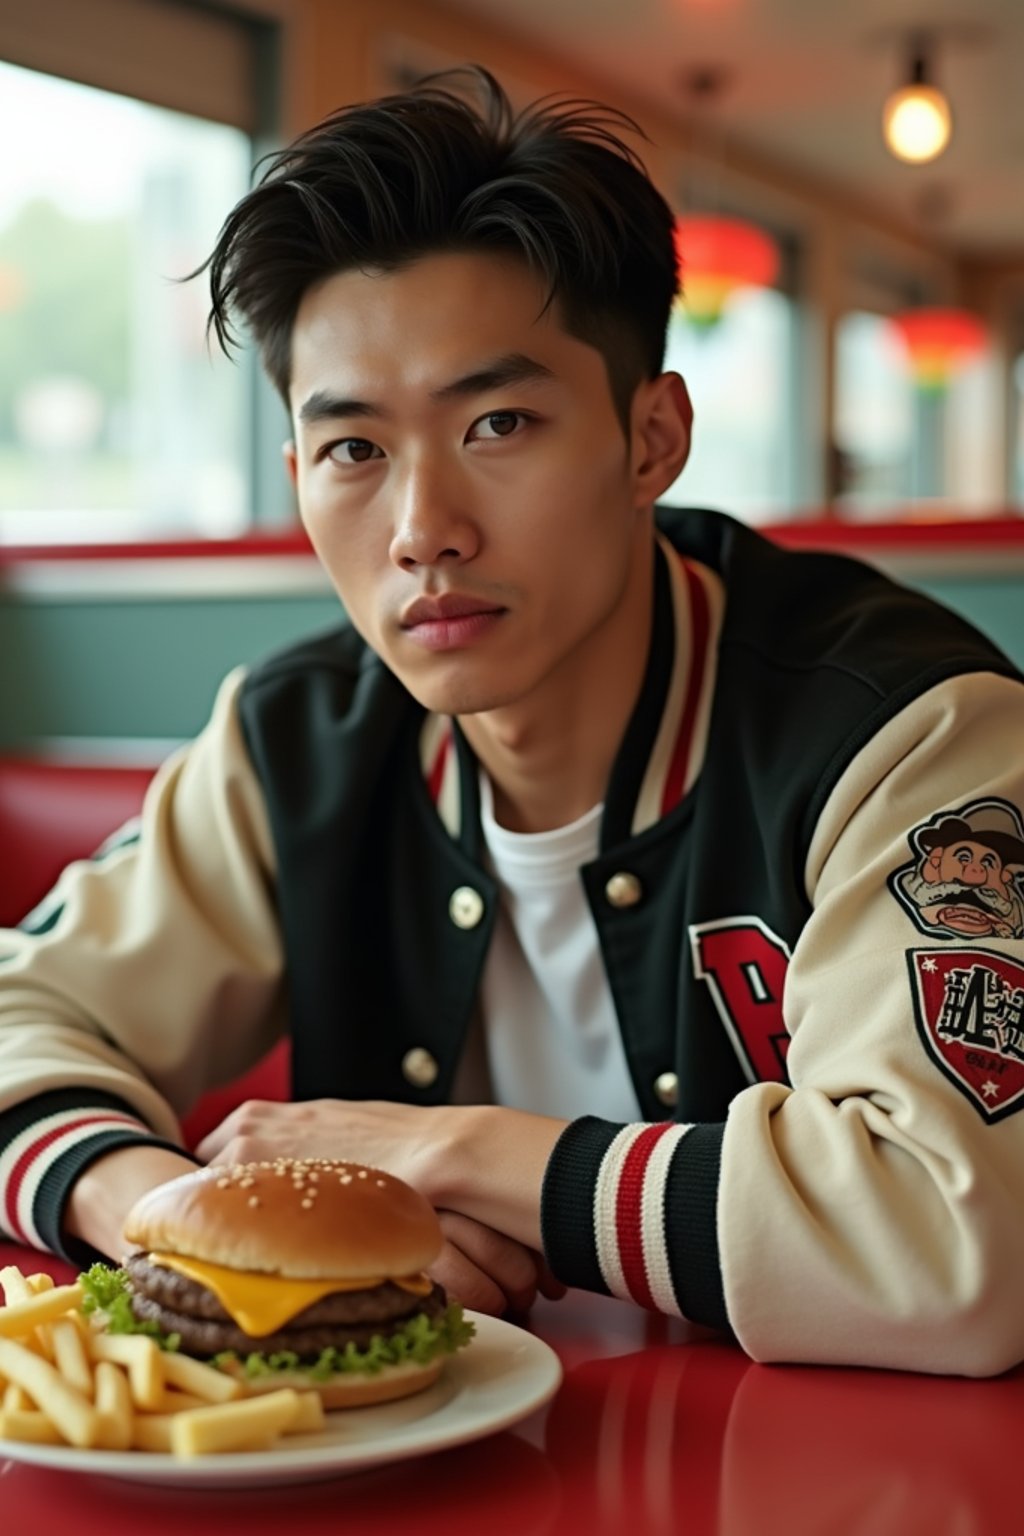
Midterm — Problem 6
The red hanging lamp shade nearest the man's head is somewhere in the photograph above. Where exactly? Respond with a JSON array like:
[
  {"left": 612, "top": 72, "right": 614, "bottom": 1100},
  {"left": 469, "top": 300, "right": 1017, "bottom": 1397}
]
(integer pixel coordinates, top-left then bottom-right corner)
[{"left": 676, "top": 214, "right": 778, "bottom": 326}]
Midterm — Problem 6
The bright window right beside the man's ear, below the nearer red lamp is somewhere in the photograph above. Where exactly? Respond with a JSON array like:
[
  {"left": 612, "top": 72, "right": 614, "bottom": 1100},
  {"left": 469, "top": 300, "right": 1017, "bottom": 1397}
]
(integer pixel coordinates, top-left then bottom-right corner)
[{"left": 662, "top": 287, "right": 800, "bottom": 522}]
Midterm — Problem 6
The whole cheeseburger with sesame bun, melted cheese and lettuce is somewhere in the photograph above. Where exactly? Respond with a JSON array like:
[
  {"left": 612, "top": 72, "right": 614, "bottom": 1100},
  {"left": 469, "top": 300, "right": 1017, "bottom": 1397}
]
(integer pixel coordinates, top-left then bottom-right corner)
[{"left": 95, "top": 1158, "right": 471, "bottom": 1407}]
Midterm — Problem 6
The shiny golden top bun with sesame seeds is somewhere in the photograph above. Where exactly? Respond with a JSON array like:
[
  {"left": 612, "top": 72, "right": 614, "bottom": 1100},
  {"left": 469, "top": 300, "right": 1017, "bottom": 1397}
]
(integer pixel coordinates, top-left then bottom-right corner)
[{"left": 124, "top": 1158, "right": 442, "bottom": 1281}]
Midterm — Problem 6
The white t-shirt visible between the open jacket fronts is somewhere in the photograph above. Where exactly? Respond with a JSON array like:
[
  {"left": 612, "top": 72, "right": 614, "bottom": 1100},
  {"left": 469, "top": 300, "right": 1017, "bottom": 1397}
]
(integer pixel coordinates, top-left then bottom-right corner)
[{"left": 469, "top": 773, "right": 642, "bottom": 1121}]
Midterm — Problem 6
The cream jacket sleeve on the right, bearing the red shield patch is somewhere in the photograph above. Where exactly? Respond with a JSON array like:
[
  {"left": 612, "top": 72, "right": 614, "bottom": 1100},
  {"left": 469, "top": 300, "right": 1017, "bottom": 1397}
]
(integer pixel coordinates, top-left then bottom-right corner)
[{"left": 718, "top": 674, "right": 1024, "bottom": 1376}]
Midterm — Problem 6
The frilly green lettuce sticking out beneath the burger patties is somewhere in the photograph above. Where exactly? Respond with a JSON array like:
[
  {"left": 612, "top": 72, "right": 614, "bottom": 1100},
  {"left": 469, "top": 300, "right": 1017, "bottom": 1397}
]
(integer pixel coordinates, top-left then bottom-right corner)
[{"left": 80, "top": 1264, "right": 476, "bottom": 1381}]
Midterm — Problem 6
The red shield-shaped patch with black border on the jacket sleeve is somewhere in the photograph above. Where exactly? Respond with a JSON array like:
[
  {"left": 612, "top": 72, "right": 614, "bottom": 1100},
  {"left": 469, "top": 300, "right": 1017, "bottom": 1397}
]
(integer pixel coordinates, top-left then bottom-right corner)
[{"left": 907, "top": 948, "right": 1024, "bottom": 1123}]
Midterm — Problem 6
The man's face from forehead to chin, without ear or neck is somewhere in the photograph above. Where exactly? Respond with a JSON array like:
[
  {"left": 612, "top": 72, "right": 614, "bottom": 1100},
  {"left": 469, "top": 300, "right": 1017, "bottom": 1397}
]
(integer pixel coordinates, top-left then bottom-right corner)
[{"left": 289, "top": 255, "right": 681, "bottom": 714}]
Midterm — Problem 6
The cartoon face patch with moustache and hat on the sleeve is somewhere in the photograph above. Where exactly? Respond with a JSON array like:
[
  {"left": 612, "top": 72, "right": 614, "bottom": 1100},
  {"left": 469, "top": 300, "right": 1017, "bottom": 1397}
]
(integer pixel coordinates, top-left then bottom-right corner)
[{"left": 889, "top": 799, "right": 1024, "bottom": 942}]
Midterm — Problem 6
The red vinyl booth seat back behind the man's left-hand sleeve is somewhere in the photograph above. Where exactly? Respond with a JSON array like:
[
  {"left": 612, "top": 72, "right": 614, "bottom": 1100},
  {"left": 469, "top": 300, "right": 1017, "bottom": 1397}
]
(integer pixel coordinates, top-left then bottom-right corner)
[{"left": 0, "top": 757, "right": 289, "bottom": 1146}]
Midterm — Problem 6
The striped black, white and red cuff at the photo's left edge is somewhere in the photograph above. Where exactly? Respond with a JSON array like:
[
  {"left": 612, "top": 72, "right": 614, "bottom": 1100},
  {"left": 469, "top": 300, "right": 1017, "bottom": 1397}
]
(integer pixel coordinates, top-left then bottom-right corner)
[{"left": 0, "top": 1089, "right": 187, "bottom": 1264}]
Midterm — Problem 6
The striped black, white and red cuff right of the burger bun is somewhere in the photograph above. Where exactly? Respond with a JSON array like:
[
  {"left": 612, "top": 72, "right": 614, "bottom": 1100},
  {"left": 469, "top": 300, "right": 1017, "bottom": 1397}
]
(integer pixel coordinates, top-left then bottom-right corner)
[{"left": 540, "top": 1117, "right": 729, "bottom": 1329}]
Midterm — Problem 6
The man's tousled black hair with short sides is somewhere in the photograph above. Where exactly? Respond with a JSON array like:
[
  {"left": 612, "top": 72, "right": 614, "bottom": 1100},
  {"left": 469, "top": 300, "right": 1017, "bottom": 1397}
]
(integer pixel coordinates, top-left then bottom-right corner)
[{"left": 193, "top": 66, "right": 677, "bottom": 427}]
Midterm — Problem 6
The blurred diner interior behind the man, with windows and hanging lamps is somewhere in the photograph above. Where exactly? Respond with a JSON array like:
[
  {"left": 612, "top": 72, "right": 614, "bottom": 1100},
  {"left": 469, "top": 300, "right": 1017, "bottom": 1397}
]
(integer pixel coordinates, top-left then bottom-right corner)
[{"left": 0, "top": 0, "right": 1024, "bottom": 759}]
